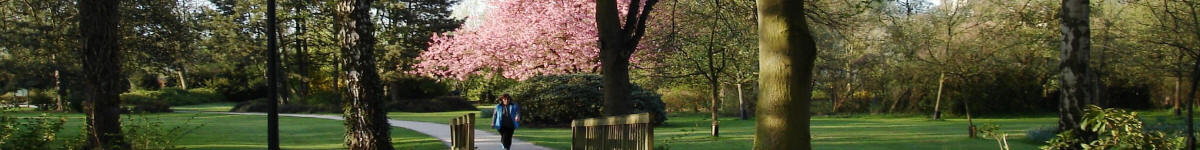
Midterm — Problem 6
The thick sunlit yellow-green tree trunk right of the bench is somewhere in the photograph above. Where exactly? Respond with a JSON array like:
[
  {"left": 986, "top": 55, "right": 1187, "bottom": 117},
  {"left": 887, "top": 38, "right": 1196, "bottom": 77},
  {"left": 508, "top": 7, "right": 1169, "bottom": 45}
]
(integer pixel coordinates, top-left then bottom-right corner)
[{"left": 754, "top": 0, "right": 817, "bottom": 150}]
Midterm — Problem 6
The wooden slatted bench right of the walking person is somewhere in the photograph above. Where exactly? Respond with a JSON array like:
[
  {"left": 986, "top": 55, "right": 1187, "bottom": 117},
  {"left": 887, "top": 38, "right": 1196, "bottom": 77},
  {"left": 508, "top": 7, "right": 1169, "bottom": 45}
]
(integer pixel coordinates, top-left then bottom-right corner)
[{"left": 571, "top": 113, "right": 654, "bottom": 150}]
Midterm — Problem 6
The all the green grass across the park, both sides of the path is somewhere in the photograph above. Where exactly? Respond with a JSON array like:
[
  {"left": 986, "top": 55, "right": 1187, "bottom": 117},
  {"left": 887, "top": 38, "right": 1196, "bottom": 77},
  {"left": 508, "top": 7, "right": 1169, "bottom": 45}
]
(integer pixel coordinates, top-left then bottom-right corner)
[{"left": 42, "top": 103, "right": 1195, "bottom": 150}]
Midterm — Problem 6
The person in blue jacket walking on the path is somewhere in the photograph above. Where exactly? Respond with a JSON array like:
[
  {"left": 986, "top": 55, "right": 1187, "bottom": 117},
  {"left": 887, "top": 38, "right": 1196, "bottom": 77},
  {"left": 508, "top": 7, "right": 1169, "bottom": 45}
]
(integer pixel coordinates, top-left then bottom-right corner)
[{"left": 492, "top": 94, "right": 521, "bottom": 150}]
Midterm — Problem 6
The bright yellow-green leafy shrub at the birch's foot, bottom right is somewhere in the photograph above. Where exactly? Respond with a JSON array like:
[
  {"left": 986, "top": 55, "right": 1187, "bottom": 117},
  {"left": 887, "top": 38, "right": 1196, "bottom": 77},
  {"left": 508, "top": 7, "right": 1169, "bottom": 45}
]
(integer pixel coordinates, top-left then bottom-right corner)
[{"left": 1042, "top": 106, "right": 1183, "bottom": 150}]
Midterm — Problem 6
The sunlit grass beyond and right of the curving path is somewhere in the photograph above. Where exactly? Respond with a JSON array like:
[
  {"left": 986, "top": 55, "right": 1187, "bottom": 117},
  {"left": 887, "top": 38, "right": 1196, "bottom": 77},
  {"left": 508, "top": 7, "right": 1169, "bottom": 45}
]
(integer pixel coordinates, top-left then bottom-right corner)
[{"left": 388, "top": 110, "right": 1200, "bottom": 150}]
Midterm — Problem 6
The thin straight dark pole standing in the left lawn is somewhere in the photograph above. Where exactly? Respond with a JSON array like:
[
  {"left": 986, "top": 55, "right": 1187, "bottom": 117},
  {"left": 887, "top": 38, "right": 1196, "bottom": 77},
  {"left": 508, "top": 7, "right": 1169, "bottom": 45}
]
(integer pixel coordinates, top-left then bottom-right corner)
[{"left": 266, "top": 0, "right": 281, "bottom": 150}]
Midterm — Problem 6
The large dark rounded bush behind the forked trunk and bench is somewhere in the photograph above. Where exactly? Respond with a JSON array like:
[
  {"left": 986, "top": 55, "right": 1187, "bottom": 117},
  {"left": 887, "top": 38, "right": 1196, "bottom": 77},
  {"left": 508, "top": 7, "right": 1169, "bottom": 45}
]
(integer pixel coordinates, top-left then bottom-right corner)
[{"left": 508, "top": 74, "right": 667, "bottom": 126}]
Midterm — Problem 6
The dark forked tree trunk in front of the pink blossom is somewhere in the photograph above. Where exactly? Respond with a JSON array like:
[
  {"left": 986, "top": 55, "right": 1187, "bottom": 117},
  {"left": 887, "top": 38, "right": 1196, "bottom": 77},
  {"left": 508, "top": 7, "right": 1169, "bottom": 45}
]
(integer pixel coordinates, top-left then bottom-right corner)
[{"left": 596, "top": 0, "right": 659, "bottom": 115}]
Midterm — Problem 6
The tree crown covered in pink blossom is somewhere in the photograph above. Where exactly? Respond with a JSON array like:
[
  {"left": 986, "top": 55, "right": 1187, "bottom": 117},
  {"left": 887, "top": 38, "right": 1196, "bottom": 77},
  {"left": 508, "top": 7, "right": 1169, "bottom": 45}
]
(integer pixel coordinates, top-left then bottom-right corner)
[{"left": 412, "top": 0, "right": 641, "bottom": 80}]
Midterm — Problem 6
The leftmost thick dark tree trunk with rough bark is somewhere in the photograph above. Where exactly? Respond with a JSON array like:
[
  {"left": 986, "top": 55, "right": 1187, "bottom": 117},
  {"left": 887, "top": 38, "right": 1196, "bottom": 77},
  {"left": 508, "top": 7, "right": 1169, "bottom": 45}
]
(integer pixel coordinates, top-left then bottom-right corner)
[{"left": 78, "top": 0, "right": 130, "bottom": 147}]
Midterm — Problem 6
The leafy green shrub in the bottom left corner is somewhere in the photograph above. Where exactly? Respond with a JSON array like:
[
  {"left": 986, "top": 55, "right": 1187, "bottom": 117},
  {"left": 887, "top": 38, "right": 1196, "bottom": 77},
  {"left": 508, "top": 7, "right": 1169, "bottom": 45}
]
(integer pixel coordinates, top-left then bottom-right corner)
[{"left": 0, "top": 114, "right": 67, "bottom": 150}]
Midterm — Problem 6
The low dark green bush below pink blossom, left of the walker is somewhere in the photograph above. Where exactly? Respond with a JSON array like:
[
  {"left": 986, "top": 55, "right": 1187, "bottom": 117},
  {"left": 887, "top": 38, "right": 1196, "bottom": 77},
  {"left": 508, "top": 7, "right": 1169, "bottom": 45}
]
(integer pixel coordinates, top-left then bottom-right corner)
[{"left": 384, "top": 96, "right": 478, "bottom": 112}]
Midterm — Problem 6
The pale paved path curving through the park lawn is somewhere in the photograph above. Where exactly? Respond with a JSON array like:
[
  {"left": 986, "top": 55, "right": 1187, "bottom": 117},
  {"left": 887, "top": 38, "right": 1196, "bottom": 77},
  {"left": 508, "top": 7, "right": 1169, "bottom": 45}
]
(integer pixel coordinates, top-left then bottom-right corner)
[{"left": 180, "top": 110, "right": 551, "bottom": 150}]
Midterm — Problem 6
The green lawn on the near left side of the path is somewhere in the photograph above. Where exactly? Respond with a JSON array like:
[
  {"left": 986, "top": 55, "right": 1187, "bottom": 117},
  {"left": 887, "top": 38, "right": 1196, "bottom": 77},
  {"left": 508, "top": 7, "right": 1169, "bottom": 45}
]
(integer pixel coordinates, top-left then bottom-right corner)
[{"left": 4, "top": 113, "right": 446, "bottom": 150}]
